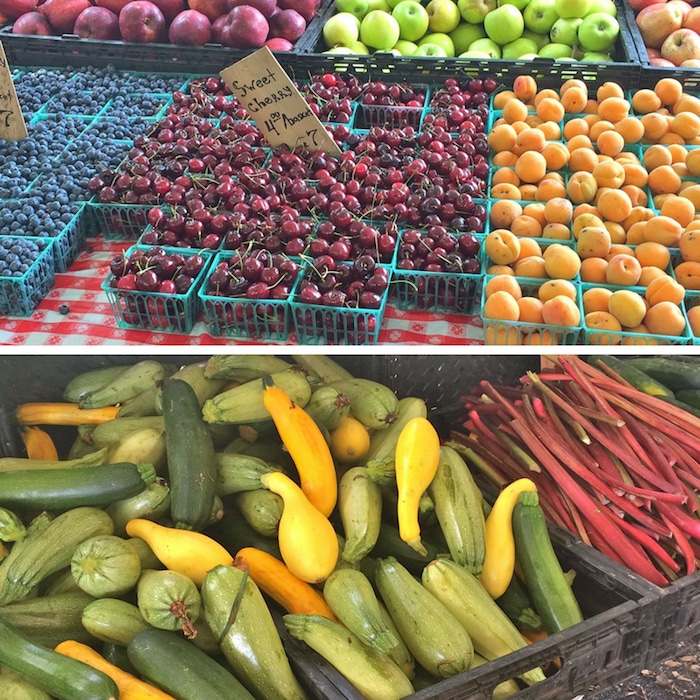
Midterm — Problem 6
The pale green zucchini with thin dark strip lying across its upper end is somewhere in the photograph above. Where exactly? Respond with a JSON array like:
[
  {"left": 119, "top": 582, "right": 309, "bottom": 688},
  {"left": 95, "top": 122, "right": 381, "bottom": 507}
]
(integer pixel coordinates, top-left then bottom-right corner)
[{"left": 202, "top": 566, "right": 307, "bottom": 700}]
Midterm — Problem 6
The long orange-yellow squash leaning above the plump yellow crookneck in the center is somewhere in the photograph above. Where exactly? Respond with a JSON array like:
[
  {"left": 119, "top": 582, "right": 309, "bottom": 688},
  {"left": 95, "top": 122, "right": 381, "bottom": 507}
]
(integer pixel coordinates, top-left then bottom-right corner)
[{"left": 263, "top": 384, "right": 338, "bottom": 517}]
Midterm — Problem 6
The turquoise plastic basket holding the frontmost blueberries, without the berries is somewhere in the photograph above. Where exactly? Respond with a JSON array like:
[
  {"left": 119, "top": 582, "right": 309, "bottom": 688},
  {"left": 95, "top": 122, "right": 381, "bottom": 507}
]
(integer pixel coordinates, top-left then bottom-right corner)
[{"left": 0, "top": 236, "right": 56, "bottom": 316}]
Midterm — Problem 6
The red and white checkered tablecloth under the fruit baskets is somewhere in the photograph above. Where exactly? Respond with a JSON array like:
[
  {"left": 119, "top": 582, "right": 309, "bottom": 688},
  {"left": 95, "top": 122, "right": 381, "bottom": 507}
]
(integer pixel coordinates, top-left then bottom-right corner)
[{"left": 0, "top": 238, "right": 484, "bottom": 346}]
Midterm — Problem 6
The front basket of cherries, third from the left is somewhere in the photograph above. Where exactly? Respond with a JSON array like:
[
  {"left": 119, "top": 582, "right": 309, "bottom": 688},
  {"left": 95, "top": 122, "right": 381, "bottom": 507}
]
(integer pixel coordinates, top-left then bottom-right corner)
[{"left": 292, "top": 255, "right": 392, "bottom": 345}]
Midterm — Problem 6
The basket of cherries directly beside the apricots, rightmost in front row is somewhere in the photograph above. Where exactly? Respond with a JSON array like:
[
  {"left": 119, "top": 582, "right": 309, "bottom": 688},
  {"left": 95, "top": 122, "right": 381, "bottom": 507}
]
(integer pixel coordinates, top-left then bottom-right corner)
[{"left": 392, "top": 226, "right": 483, "bottom": 314}]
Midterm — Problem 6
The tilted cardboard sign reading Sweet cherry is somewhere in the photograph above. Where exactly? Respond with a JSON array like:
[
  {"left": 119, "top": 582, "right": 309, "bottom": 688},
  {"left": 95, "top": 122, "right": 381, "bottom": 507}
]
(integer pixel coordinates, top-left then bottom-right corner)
[{"left": 220, "top": 46, "right": 340, "bottom": 155}]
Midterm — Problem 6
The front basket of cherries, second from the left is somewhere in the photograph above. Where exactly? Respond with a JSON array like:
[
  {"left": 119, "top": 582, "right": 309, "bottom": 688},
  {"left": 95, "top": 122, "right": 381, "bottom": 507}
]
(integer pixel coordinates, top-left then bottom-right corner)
[{"left": 198, "top": 248, "right": 300, "bottom": 342}]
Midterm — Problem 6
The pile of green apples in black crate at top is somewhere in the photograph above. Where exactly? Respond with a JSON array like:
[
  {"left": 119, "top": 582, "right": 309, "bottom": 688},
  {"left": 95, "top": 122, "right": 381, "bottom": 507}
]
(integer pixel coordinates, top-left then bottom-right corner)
[{"left": 322, "top": 0, "right": 628, "bottom": 63}]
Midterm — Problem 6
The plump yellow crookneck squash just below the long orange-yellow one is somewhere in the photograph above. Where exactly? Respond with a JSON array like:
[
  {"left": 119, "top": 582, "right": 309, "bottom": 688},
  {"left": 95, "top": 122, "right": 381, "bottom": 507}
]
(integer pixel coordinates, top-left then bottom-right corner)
[{"left": 260, "top": 472, "right": 339, "bottom": 583}]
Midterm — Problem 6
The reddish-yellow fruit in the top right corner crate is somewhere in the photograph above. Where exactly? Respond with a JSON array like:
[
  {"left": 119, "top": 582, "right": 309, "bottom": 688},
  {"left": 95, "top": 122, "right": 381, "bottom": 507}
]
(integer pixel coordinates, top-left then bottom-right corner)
[{"left": 628, "top": 0, "right": 700, "bottom": 68}]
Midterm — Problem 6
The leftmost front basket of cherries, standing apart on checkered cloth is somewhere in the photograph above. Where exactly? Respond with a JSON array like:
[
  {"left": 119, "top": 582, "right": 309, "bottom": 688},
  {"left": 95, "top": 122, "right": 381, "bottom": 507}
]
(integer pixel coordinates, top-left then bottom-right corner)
[{"left": 102, "top": 246, "right": 212, "bottom": 333}]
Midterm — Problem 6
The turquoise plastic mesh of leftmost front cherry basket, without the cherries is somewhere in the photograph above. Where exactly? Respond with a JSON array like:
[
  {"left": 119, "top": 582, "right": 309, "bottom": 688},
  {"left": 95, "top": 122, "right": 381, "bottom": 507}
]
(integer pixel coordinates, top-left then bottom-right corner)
[{"left": 102, "top": 246, "right": 211, "bottom": 334}]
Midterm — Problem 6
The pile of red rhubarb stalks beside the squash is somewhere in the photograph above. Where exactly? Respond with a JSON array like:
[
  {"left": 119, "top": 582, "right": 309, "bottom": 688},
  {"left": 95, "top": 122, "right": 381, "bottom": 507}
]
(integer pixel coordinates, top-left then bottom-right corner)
[{"left": 452, "top": 355, "right": 700, "bottom": 586}]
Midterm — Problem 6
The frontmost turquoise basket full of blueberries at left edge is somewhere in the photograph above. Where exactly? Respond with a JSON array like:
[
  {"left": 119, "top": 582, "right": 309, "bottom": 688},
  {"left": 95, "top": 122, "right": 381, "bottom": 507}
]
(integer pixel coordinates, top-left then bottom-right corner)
[{"left": 0, "top": 236, "right": 56, "bottom": 316}]
